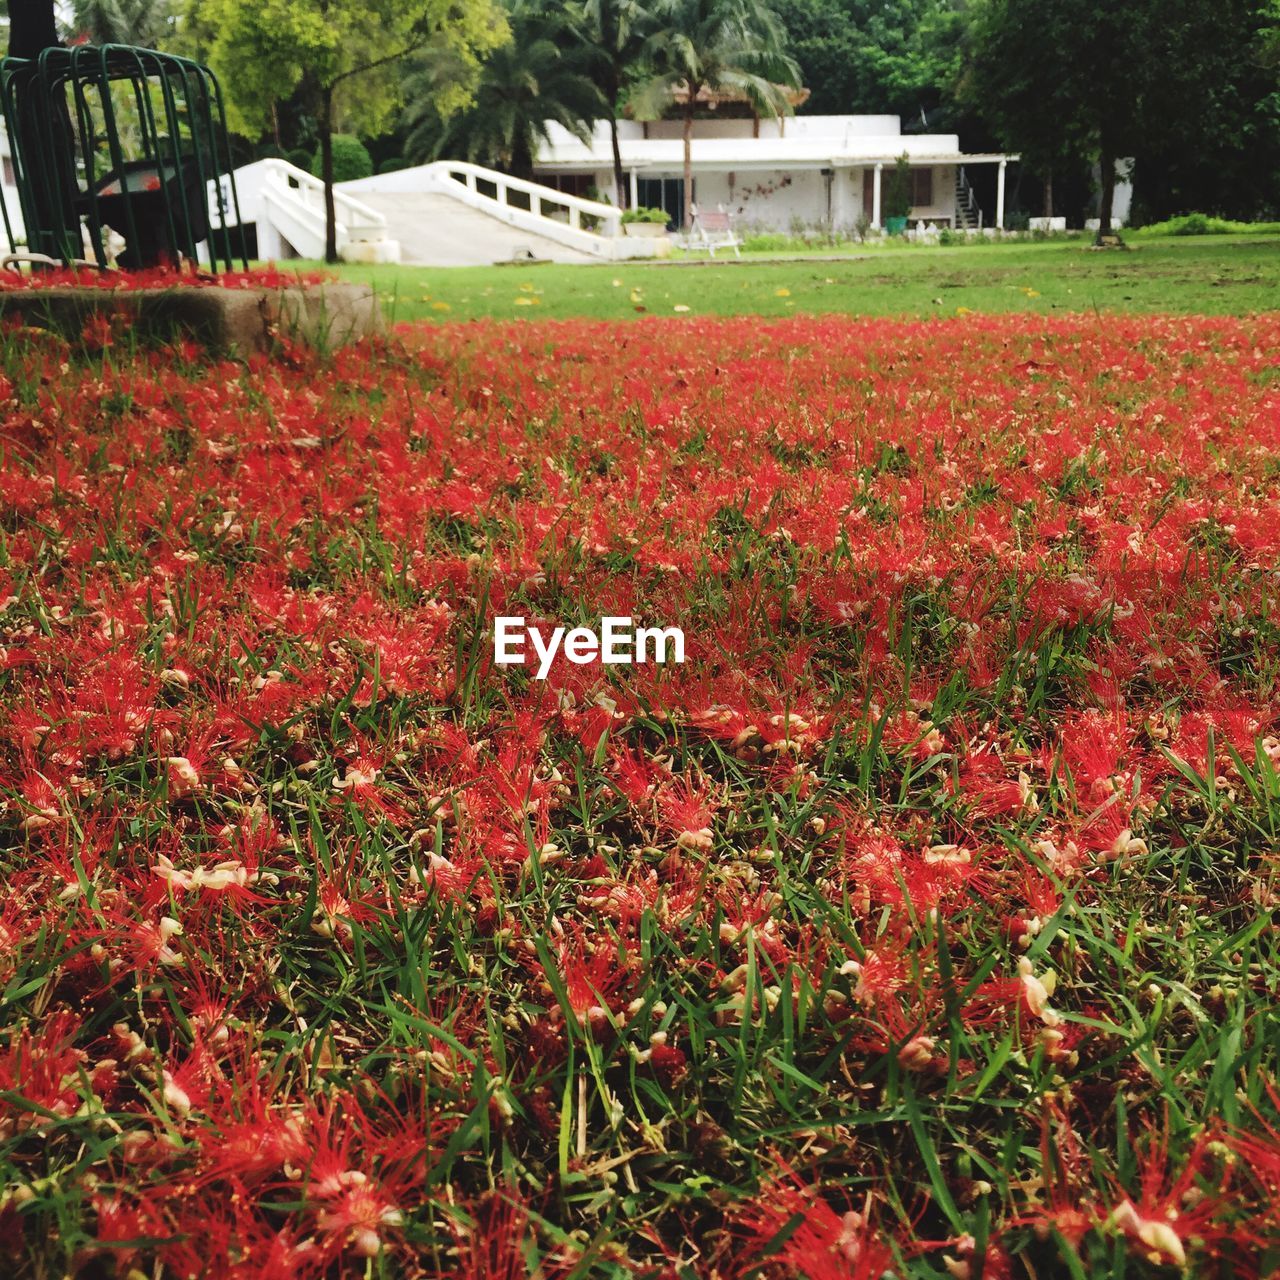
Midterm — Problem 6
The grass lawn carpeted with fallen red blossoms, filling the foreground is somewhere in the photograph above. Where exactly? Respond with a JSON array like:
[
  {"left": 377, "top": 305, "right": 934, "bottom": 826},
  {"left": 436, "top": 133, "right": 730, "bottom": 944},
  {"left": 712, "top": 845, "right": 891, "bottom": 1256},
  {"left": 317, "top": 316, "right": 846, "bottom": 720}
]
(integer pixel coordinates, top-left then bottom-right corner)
[{"left": 0, "top": 282, "right": 1280, "bottom": 1280}]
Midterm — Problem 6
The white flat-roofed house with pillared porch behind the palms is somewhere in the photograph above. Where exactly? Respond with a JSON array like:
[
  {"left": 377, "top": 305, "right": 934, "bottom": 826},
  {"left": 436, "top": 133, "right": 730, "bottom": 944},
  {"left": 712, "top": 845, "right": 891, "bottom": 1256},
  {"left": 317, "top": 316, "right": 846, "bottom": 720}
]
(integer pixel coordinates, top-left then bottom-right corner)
[{"left": 534, "top": 115, "right": 1018, "bottom": 232}]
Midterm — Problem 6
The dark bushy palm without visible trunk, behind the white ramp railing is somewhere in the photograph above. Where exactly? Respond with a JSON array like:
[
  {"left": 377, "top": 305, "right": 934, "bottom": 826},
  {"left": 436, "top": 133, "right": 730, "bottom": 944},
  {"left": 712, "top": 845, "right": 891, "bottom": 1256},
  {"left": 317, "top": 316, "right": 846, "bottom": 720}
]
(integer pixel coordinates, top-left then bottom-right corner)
[{"left": 404, "top": 0, "right": 605, "bottom": 178}]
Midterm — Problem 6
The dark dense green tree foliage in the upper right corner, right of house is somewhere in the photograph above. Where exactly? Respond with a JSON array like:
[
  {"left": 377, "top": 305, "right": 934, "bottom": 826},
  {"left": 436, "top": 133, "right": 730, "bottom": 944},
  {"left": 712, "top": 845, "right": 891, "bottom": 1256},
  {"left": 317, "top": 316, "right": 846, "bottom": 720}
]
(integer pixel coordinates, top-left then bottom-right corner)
[{"left": 959, "top": 0, "right": 1280, "bottom": 225}]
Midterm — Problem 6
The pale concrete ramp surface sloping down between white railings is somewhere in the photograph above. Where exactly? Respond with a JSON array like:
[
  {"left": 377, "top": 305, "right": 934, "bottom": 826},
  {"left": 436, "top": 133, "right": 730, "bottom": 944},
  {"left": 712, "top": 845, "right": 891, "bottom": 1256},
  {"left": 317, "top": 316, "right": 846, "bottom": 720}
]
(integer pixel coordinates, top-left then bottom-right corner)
[{"left": 345, "top": 189, "right": 599, "bottom": 266}]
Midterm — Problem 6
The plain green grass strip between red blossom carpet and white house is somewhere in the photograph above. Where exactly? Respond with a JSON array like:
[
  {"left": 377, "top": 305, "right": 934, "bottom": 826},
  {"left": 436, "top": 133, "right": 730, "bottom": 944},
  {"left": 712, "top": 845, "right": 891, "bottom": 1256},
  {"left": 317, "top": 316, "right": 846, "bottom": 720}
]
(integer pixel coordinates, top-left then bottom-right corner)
[{"left": 288, "top": 236, "right": 1280, "bottom": 321}]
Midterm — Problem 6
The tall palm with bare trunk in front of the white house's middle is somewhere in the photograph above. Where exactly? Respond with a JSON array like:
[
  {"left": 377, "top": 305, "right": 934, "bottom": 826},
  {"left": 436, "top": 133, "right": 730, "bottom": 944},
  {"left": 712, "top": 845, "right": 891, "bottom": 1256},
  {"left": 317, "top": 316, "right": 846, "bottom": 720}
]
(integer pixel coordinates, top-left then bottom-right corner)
[{"left": 636, "top": 0, "right": 800, "bottom": 230}]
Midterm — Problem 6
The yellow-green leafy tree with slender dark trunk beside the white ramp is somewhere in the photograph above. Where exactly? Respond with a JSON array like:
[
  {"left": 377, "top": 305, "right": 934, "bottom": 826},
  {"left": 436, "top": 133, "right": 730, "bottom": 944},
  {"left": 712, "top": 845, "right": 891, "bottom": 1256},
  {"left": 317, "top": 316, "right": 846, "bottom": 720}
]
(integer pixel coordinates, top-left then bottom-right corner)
[{"left": 201, "top": 0, "right": 506, "bottom": 262}]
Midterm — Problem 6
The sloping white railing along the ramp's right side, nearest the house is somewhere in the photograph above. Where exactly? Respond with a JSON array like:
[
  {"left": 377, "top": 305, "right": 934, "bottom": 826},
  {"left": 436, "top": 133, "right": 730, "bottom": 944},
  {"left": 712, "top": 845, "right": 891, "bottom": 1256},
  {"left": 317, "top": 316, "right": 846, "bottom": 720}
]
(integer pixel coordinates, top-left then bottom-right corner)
[{"left": 343, "top": 160, "right": 655, "bottom": 259}]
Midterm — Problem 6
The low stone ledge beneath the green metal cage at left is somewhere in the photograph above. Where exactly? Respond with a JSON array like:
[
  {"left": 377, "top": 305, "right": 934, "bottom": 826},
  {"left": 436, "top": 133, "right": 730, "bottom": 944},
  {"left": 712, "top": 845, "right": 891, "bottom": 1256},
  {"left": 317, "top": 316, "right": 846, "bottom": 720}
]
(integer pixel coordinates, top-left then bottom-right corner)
[{"left": 0, "top": 282, "right": 383, "bottom": 355}]
